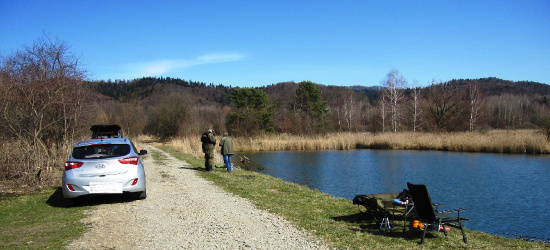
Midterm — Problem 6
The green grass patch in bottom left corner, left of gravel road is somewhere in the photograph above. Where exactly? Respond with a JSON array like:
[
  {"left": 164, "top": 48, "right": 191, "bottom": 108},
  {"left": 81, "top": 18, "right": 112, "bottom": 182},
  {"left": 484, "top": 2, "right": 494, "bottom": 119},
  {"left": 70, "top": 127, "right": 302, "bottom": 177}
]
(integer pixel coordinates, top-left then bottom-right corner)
[{"left": 0, "top": 188, "right": 89, "bottom": 249}]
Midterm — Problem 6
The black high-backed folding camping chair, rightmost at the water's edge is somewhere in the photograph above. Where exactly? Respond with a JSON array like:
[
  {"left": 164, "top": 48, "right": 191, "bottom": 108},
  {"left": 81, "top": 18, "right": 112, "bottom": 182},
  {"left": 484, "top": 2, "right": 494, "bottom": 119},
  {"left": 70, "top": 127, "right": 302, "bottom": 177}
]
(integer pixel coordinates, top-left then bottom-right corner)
[{"left": 407, "top": 182, "right": 468, "bottom": 244}]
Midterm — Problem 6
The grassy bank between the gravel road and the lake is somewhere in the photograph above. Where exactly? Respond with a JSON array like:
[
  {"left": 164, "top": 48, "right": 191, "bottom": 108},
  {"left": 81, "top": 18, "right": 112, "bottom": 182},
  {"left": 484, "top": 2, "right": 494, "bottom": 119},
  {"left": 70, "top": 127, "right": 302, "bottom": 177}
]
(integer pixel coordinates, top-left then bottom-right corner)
[{"left": 157, "top": 146, "right": 548, "bottom": 249}]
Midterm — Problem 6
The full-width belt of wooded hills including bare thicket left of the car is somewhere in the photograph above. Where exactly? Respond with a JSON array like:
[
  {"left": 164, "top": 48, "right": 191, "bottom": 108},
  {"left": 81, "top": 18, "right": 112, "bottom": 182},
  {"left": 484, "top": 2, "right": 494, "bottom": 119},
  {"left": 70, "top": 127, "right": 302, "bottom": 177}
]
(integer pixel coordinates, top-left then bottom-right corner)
[{"left": 0, "top": 37, "right": 550, "bottom": 184}]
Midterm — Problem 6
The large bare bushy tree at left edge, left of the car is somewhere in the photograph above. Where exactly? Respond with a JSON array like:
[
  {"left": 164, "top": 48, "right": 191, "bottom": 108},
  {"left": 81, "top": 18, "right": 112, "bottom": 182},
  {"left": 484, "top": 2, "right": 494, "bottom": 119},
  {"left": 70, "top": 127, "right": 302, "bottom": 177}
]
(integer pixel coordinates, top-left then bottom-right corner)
[{"left": 0, "top": 35, "right": 86, "bottom": 183}]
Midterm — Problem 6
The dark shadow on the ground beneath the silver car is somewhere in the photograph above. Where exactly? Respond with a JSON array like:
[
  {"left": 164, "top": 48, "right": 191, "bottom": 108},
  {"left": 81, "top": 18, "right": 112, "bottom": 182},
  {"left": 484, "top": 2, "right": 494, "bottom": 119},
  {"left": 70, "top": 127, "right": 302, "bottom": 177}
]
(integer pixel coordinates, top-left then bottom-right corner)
[{"left": 46, "top": 187, "right": 141, "bottom": 208}]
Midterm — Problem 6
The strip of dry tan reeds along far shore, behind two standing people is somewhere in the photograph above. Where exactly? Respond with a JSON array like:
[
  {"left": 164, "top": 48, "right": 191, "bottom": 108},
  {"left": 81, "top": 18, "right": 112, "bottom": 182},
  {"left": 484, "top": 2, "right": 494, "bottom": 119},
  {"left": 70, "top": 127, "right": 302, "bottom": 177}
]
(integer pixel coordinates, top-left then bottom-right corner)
[{"left": 167, "top": 130, "right": 550, "bottom": 155}]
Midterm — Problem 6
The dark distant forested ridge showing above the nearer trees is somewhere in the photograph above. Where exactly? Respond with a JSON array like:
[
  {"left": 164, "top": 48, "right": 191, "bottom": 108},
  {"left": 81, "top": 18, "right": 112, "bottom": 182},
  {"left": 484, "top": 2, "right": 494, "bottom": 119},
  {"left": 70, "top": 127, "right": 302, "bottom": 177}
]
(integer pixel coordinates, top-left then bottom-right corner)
[{"left": 90, "top": 77, "right": 550, "bottom": 105}]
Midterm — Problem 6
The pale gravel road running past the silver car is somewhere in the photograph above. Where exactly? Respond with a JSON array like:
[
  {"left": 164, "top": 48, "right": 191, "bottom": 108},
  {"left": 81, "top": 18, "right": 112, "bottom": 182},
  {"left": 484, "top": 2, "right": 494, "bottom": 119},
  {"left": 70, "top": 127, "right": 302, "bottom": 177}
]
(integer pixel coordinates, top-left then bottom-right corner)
[{"left": 67, "top": 145, "right": 328, "bottom": 249}]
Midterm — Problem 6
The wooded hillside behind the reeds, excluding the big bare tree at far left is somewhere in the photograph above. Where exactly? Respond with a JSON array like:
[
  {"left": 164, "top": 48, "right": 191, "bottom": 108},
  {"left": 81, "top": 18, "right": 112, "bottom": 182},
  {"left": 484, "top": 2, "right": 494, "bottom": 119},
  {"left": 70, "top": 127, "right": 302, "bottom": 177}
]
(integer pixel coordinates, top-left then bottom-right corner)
[{"left": 87, "top": 73, "right": 550, "bottom": 138}]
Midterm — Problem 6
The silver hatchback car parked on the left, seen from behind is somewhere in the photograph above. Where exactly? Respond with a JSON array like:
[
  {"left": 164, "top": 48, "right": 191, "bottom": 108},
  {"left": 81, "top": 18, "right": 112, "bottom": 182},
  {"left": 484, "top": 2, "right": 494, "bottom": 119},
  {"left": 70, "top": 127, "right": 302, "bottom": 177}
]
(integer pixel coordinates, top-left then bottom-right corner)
[{"left": 62, "top": 138, "right": 147, "bottom": 199}]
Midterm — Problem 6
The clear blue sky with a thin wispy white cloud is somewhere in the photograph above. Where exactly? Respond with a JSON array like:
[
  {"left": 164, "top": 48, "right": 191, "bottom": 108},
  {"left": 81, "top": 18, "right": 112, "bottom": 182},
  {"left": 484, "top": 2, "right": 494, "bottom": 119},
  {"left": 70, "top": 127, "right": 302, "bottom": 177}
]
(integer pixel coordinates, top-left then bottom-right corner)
[{"left": 0, "top": 0, "right": 550, "bottom": 87}]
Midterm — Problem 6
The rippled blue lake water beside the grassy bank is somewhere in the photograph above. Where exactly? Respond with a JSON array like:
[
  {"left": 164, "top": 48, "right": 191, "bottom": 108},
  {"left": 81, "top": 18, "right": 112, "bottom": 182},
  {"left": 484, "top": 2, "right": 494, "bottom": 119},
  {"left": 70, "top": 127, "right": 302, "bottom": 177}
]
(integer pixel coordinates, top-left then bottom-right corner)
[{"left": 243, "top": 150, "right": 550, "bottom": 239}]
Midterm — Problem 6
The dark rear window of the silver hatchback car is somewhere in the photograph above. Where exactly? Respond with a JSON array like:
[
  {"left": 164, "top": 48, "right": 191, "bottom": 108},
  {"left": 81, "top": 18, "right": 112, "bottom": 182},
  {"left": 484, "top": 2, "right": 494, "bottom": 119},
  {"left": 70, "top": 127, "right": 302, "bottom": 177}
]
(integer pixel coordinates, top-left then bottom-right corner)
[{"left": 73, "top": 144, "right": 130, "bottom": 159}]
